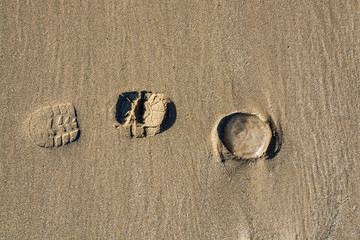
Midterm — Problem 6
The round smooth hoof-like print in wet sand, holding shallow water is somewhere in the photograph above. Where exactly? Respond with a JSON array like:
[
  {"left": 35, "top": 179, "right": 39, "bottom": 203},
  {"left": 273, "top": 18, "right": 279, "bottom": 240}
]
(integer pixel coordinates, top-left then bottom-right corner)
[{"left": 213, "top": 113, "right": 281, "bottom": 161}]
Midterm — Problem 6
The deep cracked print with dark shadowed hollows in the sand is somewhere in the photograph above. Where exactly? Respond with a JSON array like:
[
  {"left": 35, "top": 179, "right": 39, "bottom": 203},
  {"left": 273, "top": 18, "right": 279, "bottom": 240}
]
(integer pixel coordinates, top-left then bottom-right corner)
[{"left": 111, "top": 91, "right": 176, "bottom": 138}]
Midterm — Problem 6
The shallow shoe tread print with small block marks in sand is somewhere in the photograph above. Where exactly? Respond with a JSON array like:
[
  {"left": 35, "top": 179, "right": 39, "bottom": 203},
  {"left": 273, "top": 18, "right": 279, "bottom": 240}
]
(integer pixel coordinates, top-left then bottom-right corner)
[{"left": 29, "top": 103, "right": 80, "bottom": 148}]
